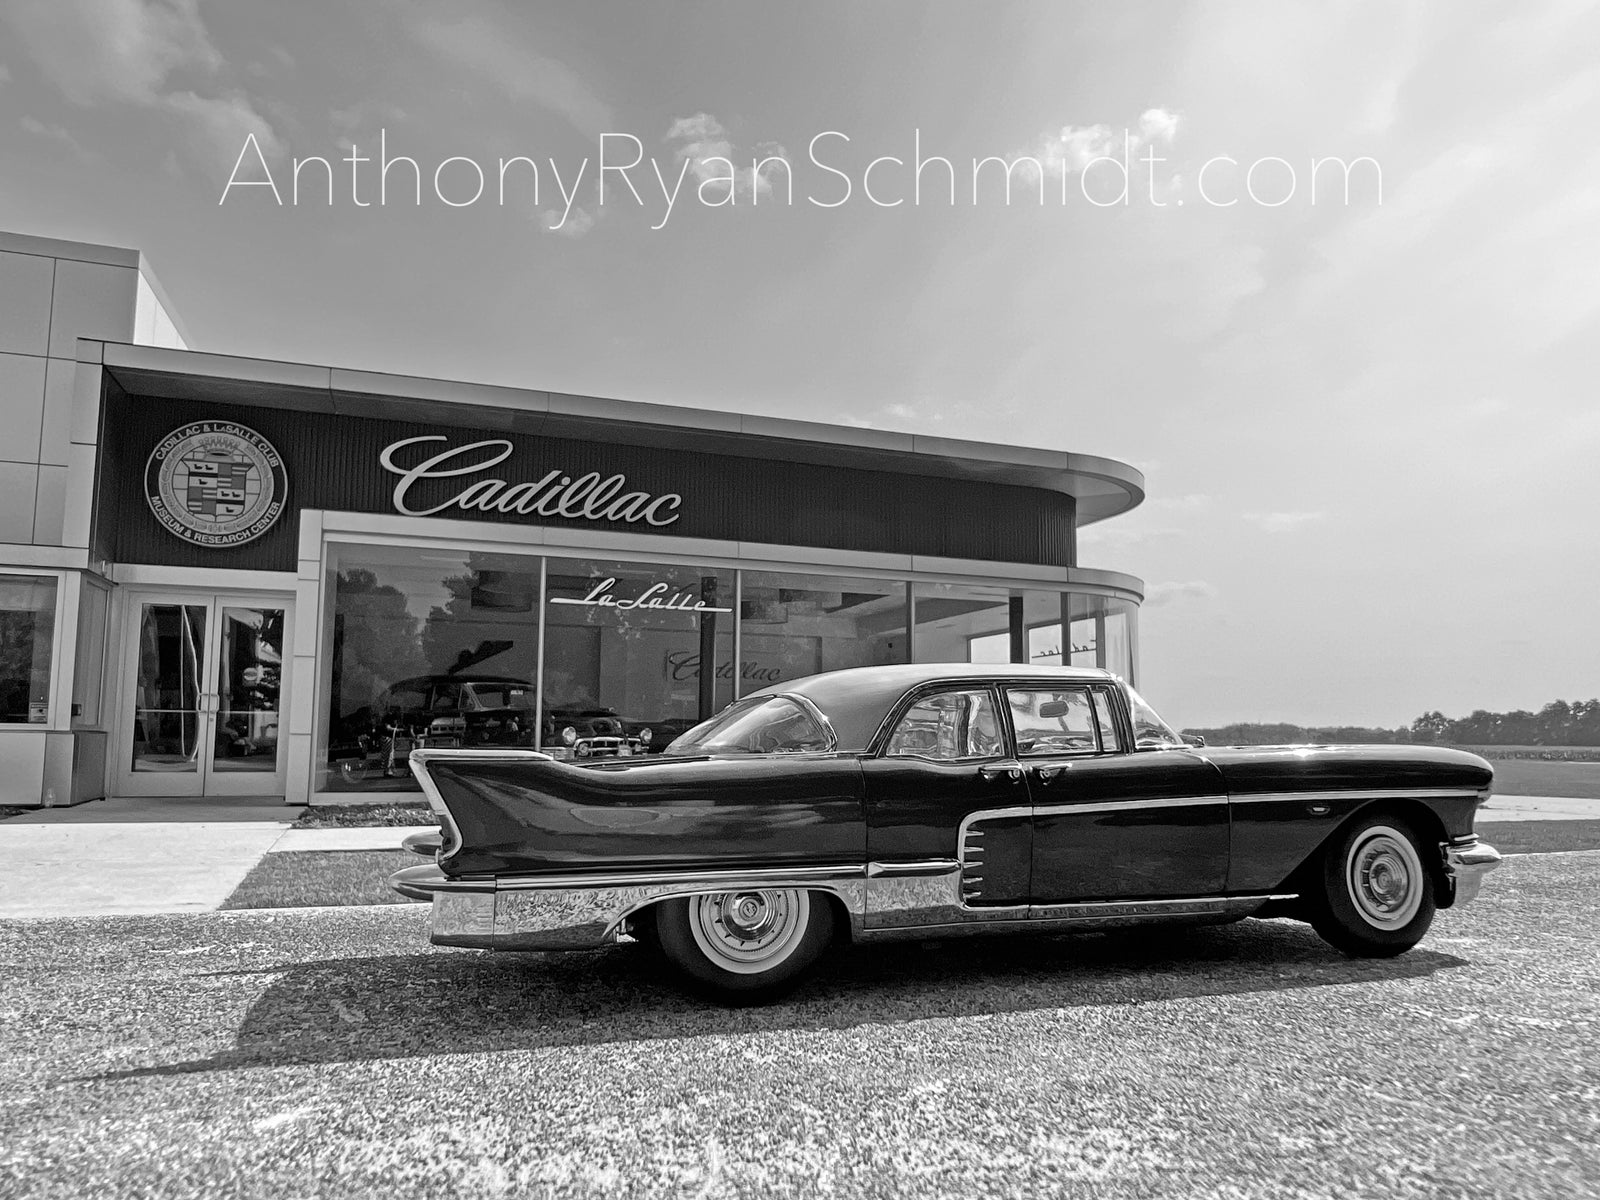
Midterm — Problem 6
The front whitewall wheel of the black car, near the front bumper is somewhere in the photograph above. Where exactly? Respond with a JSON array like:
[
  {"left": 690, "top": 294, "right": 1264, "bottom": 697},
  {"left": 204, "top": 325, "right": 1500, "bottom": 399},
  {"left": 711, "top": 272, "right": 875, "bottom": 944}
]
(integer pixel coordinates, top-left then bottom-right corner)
[{"left": 1312, "top": 813, "right": 1434, "bottom": 958}]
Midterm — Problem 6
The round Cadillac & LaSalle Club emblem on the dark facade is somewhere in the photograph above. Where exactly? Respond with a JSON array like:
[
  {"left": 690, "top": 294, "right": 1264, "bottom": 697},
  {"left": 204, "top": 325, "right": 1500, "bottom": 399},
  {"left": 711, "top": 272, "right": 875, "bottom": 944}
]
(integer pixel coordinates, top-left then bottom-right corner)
[{"left": 144, "top": 421, "right": 290, "bottom": 546}]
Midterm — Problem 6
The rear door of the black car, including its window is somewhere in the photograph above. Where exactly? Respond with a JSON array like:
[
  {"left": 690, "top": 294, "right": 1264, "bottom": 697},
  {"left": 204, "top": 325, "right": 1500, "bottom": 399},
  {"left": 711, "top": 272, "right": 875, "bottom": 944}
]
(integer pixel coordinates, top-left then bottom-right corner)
[{"left": 861, "top": 683, "right": 1032, "bottom": 912}]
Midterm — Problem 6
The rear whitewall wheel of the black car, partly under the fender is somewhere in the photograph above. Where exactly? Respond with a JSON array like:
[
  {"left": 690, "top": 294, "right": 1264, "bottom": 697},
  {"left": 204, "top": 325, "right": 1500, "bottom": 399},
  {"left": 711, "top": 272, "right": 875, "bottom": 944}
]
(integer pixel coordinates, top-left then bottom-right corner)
[{"left": 654, "top": 888, "right": 834, "bottom": 1003}]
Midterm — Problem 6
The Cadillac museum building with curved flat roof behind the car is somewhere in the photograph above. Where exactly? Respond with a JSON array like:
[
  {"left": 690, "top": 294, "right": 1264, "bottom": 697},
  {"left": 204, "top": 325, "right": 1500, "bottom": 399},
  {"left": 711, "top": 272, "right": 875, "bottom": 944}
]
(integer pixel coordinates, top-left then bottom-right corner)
[{"left": 0, "top": 234, "right": 1144, "bottom": 805}]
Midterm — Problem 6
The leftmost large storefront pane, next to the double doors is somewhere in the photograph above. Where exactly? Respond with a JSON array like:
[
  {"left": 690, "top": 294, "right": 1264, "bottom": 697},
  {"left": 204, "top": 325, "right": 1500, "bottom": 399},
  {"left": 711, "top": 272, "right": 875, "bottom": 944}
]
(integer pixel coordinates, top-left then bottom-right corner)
[{"left": 320, "top": 546, "right": 539, "bottom": 792}]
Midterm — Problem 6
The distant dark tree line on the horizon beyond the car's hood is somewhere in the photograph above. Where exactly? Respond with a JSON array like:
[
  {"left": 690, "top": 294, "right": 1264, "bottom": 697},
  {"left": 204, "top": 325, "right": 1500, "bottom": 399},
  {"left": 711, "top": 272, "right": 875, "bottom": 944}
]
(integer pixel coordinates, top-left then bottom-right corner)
[{"left": 1184, "top": 699, "right": 1600, "bottom": 746}]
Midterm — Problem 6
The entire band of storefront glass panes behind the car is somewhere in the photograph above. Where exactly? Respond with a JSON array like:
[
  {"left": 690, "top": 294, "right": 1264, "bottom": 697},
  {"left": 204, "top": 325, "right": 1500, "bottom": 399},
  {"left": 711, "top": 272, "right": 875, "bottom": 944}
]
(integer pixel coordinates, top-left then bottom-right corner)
[{"left": 312, "top": 544, "right": 1136, "bottom": 792}]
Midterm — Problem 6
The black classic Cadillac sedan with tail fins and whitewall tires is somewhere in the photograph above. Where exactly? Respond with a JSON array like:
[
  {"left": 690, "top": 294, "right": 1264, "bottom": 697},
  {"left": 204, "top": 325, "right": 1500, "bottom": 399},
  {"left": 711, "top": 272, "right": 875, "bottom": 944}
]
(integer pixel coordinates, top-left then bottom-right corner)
[{"left": 392, "top": 664, "right": 1499, "bottom": 1000}]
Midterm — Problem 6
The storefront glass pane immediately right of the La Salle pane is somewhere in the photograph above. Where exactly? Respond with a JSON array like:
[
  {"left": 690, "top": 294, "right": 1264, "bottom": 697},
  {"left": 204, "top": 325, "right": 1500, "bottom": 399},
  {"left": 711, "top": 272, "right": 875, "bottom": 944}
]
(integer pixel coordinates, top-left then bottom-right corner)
[{"left": 739, "top": 571, "right": 907, "bottom": 694}]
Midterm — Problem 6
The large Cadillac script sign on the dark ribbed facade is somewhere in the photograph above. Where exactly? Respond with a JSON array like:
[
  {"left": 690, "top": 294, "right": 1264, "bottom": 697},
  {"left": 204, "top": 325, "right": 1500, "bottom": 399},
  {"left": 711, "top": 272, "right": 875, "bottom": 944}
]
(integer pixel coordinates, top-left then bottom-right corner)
[{"left": 378, "top": 434, "right": 683, "bottom": 526}]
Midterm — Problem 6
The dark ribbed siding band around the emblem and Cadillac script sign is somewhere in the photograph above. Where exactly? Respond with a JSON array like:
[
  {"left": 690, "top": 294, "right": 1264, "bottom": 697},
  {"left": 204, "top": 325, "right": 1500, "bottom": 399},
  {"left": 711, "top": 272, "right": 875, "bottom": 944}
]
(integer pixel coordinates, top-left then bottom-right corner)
[{"left": 98, "top": 392, "right": 1075, "bottom": 571}]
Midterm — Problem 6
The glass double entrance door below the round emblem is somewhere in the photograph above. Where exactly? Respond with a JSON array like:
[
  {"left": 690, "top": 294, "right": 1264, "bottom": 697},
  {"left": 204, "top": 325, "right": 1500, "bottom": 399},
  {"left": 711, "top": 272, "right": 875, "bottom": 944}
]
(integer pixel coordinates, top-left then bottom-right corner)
[{"left": 115, "top": 594, "right": 291, "bottom": 797}]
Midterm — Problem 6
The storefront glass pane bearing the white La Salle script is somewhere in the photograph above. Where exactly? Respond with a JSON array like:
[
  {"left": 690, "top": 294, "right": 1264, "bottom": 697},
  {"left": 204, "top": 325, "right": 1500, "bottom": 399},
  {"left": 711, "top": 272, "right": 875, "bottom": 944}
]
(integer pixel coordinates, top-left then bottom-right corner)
[{"left": 542, "top": 558, "right": 734, "bottom": 758}]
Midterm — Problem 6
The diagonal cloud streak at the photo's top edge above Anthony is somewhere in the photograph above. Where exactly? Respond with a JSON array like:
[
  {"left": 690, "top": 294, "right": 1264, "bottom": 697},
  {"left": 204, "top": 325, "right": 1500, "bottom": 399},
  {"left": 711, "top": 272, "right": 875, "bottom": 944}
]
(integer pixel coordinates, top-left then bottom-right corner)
[{"left": 406, "top": 6, "right": 616, "bottom": 139}]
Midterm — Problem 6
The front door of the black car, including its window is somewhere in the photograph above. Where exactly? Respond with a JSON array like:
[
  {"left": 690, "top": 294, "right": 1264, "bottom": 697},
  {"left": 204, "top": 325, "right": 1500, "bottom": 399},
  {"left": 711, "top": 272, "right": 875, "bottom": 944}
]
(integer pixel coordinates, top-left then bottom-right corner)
[{"left": 1005, "top": 683, "right": 1229, "bottom": 904}]
